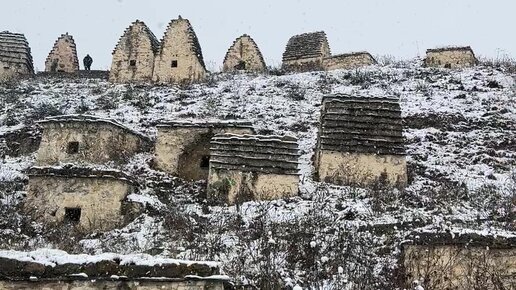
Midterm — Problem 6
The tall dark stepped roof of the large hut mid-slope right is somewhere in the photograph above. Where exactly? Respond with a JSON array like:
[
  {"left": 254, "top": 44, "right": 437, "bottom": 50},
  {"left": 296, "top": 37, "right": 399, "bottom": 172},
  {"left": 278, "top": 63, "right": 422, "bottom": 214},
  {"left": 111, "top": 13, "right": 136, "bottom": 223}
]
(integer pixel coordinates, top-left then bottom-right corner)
[{"left": 318, "top": 95, "right": 405, "bottom": 155}]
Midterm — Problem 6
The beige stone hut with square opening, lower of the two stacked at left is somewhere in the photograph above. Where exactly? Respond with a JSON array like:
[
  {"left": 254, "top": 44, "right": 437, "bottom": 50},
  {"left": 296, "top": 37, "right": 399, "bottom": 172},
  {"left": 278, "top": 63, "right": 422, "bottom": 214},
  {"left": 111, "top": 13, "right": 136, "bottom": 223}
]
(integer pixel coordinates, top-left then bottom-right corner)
[{"left": 24, "top": 166, "right": 135, "bottom": 232}]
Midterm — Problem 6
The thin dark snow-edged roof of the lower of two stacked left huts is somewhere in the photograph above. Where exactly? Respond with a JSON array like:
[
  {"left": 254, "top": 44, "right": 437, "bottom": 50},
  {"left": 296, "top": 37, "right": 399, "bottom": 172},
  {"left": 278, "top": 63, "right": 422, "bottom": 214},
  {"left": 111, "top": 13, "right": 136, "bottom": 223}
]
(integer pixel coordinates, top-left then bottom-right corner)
[{"left": 27, "top": 164, "right": 136, "bottom": 184}]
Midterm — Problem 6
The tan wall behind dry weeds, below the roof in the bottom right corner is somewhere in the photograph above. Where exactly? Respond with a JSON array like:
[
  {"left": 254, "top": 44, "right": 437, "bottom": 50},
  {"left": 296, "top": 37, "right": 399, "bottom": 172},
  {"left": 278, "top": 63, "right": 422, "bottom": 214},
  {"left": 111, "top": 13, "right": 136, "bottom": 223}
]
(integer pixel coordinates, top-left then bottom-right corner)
[{"left": 403, "top": 245, "right": 516, "bottom": 290}]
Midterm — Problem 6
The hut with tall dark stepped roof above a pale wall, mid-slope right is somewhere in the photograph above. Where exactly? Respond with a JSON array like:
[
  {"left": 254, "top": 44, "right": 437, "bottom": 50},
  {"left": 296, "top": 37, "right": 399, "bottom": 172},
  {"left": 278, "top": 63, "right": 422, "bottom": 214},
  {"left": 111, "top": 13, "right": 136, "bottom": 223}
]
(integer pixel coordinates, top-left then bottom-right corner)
[{"left": 315, "top": 95, "right": 407, "bottom": 187}]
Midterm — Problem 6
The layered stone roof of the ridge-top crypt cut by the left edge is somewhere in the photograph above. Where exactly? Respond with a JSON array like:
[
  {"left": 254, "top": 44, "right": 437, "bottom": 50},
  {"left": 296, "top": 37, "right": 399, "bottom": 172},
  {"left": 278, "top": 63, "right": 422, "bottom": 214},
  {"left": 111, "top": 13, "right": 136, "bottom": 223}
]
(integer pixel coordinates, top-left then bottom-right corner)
[{"left": 0, "top": 31, "right": 34, "bottom": 73}]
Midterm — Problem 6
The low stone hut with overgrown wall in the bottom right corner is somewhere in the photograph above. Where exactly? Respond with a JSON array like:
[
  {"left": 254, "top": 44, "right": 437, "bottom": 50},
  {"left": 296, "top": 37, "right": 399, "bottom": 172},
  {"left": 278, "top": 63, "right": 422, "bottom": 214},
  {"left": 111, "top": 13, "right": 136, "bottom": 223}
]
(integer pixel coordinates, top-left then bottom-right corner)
[{"left": 401, "top": 232, "right": 516, "bottom": 290}]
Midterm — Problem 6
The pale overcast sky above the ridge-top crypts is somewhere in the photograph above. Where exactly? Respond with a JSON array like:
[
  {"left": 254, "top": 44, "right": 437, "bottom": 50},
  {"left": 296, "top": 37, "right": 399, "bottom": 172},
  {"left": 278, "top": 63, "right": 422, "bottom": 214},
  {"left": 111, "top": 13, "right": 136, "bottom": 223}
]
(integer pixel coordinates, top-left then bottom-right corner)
[{"left": 0, "top": 0, "right": 516, "bottom": 70}]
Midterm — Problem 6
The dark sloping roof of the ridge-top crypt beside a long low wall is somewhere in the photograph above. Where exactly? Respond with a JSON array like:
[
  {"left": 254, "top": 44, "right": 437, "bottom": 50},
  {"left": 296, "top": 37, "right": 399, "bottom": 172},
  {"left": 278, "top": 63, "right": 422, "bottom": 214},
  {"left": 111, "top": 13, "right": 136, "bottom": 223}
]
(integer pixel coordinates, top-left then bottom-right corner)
[{"left": 283, "top": 31, "right": 330, "bottom": 61}]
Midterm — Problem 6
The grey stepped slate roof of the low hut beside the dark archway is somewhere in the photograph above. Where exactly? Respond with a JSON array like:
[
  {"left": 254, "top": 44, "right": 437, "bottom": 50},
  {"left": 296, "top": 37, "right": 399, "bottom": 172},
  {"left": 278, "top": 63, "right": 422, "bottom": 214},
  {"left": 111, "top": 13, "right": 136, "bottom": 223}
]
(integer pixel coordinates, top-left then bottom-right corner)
[{"left": 210, "top": 134, "right": 300, "bottom": 175}]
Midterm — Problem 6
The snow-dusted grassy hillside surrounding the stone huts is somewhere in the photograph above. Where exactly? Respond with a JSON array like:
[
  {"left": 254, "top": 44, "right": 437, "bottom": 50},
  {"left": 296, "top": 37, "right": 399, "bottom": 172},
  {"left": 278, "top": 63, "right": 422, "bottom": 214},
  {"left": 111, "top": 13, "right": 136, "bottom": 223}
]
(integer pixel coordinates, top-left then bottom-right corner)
[{"left": 0, "top": 61, "right": 516, "bottom": 289}]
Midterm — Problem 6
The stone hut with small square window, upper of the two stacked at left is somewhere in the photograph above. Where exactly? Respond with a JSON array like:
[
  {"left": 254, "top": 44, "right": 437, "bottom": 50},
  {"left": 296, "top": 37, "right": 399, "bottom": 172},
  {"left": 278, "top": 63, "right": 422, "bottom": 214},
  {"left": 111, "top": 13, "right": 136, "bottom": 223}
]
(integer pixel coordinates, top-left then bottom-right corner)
[{"left": 36, "top": 115, "right": 151, "bottom": 166}]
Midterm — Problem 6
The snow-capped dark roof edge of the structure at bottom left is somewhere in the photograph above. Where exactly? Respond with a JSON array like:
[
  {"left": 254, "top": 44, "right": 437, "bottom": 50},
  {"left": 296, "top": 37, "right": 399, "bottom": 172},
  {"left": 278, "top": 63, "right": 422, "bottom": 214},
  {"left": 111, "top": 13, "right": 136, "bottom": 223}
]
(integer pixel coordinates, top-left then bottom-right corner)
[{"left": 0, "top": 249, "right": 221, "bottom": 280}]
